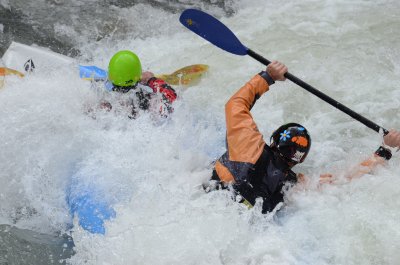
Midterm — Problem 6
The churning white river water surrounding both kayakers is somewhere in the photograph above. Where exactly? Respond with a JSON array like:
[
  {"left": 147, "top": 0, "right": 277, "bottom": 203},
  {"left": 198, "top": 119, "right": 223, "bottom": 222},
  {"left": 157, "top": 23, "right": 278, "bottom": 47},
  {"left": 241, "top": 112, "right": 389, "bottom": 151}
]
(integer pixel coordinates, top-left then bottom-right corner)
[{"left": 0, "top": 0, "right": 400, "bottom": 264}]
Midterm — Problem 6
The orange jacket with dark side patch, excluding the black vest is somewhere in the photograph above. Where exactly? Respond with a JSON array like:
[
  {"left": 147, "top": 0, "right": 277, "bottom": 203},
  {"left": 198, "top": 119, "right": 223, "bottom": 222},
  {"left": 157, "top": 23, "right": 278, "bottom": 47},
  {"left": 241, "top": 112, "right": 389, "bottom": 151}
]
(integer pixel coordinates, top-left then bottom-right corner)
[{"left": 215, "top": 75, "right": 269, "bottom": 183}]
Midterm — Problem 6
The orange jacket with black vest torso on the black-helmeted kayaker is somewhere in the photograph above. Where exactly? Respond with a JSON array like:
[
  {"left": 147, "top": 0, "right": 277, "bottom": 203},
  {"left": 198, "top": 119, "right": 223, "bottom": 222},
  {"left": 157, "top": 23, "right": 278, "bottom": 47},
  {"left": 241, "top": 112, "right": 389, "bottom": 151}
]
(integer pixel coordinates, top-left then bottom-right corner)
[{"left": 213, "top": 75, "right": 297, "bottom": 213}]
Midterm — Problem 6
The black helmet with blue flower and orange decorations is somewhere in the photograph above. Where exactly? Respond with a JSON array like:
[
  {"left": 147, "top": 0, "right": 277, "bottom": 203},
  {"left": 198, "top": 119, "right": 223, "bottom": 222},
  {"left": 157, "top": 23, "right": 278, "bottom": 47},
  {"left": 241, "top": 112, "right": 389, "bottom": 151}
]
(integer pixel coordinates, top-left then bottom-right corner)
[{"left": 271, "top": 123, "right": 311, "bottom": 164}]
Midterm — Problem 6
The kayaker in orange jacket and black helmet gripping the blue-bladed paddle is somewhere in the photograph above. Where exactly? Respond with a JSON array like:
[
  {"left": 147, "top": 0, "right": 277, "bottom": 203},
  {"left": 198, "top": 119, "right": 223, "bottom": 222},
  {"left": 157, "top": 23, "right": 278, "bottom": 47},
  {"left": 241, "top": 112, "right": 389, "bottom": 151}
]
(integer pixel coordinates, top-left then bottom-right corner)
[{"left": 203, "top": 61, "right": 400, "bottom": 213}]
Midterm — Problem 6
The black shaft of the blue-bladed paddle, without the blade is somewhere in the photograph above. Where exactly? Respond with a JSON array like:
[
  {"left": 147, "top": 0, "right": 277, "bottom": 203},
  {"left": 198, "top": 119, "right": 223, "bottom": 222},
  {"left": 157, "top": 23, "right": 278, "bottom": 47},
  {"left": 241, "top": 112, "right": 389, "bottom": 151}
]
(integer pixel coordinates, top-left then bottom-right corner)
[{"left": 247, "top": 49, "right": 389, "bottom": 135}]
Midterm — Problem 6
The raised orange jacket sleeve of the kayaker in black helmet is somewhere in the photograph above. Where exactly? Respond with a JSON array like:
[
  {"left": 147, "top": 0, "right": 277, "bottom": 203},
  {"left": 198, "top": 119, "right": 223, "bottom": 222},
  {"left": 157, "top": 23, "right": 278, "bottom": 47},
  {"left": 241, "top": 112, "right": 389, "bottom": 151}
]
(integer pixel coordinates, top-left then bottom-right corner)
[{"left": 225, "top": 75, "right": 269, "bottom": 164}]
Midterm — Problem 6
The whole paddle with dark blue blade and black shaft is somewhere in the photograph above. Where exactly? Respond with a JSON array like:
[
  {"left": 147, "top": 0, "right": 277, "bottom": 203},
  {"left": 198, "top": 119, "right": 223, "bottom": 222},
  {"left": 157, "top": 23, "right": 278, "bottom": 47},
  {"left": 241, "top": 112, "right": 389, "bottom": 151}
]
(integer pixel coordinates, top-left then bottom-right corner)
[{"left": 179, "top": 9, "right": 389, "bottom": 135}]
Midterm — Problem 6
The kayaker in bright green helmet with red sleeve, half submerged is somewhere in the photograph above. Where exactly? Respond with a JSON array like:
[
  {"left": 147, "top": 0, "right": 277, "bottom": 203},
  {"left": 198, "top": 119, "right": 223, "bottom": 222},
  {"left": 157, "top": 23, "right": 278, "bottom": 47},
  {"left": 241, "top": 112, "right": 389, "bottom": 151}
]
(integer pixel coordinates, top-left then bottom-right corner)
[{"left": 100, "top": 50, "right": 177, "bottom": 118}]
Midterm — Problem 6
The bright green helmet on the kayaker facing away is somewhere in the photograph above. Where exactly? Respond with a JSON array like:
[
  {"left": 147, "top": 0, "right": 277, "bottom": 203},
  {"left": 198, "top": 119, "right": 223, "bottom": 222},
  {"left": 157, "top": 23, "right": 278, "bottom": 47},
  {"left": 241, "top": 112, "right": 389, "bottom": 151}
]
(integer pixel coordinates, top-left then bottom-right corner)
[{"left": 108, "top": 51, "right": 142, "bottom": 86}]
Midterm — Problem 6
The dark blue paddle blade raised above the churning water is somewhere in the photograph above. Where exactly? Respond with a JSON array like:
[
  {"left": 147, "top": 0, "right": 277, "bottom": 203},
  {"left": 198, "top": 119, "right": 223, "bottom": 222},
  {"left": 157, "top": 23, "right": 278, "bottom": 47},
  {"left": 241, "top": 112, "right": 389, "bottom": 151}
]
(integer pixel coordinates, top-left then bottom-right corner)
[{"left": 179, "top": 9, "right": 248, "bottom": 55}]
